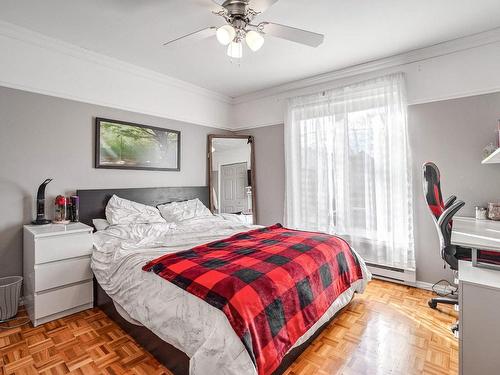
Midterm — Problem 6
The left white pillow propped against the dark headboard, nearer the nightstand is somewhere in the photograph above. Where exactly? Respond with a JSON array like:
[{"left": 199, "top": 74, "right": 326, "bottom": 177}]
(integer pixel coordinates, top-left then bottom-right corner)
[{"left": 106, "top": 195, "right": 165, "bottom": 225}]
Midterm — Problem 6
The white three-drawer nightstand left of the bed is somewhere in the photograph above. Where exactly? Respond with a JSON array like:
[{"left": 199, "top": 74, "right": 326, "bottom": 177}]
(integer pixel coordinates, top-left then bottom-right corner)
[{"left": 23, "top": 223, "right": 94, "bottom": 327}]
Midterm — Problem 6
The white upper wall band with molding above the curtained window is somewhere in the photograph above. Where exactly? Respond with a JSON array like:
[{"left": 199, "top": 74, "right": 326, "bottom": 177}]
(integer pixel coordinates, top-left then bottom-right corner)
[{"left": 231, "top": 30, "right": 500, "bottom": 129}]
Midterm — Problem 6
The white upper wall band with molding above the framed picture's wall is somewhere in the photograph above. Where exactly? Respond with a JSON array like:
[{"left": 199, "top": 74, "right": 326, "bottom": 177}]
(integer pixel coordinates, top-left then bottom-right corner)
[{"left": 0, "top": 22, "right": 231, "bottom": 128}]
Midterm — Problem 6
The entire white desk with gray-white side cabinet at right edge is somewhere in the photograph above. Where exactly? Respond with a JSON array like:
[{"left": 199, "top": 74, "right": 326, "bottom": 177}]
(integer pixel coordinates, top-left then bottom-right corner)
[{"left": 451, "top": 217, "right": 500, "bottom": 375}]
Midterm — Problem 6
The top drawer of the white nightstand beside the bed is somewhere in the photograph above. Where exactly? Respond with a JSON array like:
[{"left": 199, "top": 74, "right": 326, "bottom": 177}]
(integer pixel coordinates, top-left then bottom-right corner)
[{"left": 35, "top": 232, "right": 92, "bottom": 264}]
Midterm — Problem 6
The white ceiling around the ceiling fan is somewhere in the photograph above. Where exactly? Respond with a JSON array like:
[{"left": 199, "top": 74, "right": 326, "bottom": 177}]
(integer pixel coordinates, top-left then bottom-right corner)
[{"left": 0, "top": 0, "right": 500, "bottom": 97}]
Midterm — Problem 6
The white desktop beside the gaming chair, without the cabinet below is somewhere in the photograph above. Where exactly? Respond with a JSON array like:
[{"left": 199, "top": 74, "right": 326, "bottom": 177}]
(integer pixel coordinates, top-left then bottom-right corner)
[{"left": 451, "top": 217, "right": 500, "bottom": 269}]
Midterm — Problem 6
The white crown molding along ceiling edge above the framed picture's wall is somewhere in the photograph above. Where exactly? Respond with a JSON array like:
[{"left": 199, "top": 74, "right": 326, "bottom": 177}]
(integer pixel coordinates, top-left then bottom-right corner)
[{"left": 0, "top": 21, "right": 233, "bottom": 104}]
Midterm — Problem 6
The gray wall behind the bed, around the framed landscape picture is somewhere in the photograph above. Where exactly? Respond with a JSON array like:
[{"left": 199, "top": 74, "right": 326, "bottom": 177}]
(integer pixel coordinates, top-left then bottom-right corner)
[{"left": 0, "top": 87, "right": 227, "bottom": 277}]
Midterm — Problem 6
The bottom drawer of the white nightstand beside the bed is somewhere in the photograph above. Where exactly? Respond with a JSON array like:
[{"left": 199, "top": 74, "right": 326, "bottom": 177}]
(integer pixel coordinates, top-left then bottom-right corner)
[{"left": 35, "top": 280, "right": 94, "bottom": 319}]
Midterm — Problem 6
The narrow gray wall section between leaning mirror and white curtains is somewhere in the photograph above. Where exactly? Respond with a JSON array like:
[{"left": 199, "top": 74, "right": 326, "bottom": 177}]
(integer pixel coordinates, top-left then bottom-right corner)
[{"left": 237, "top": 125, "right": 285, "bottom": 225}]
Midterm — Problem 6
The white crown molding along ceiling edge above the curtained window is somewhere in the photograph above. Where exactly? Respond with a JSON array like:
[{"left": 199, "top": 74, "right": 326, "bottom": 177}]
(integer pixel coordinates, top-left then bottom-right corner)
[{"left": 232, "top": 27, "right": 500, "bottom": 105}]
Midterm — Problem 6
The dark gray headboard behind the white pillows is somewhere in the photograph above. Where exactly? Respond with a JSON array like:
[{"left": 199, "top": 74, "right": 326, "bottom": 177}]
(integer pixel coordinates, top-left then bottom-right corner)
[{"left": 76, "top": 186, "right": 209, "bottom": 226}]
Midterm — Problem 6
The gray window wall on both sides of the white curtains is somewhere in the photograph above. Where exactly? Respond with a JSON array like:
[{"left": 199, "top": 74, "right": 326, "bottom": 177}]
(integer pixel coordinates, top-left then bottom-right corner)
[{"left": 236, "top": 93, "right": 500, "bottom": 283}]
